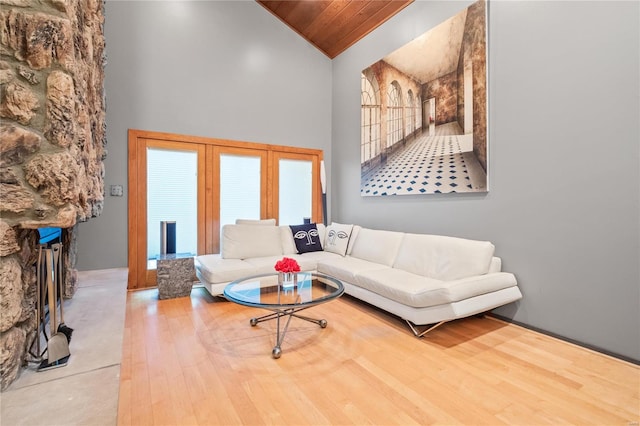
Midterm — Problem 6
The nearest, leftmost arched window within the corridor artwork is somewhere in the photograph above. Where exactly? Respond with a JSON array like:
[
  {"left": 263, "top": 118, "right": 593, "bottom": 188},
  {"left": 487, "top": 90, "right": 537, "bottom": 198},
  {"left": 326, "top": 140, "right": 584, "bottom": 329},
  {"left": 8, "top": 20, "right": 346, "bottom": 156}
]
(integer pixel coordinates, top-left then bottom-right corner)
[{"left": 360, "top": 70, "right": 381, "bottom": 163}]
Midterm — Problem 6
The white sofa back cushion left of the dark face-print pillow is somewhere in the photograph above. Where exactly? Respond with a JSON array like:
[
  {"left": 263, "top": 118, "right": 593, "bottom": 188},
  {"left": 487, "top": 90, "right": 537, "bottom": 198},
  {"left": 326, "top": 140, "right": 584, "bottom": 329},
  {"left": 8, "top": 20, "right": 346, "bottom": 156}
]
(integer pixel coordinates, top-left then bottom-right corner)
[{"left": 221, "top": 225, "right": 282, "bottom": 259}]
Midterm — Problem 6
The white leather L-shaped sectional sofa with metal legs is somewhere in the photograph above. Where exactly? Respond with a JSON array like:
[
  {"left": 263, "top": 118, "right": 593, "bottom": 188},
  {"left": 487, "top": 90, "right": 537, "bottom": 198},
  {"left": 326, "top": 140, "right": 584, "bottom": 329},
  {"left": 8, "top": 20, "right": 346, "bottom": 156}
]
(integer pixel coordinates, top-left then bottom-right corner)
[{"left": 195, "top": 220, "right": 522, "bottom": 336}]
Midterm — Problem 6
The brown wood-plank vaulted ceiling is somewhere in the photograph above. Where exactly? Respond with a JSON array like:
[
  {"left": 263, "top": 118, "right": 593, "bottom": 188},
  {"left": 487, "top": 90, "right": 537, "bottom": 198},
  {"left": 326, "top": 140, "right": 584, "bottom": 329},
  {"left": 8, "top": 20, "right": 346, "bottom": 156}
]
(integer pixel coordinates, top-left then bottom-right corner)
[{"left": 257, "top": 0, "right": 414, "bottom": 59}]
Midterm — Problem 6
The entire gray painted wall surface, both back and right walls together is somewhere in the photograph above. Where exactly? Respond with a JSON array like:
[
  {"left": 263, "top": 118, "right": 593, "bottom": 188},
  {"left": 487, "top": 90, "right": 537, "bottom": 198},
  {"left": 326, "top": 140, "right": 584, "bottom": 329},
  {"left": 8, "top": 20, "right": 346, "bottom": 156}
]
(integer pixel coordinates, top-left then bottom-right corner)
[{"left": 78, "top": 1, "right": 640, "bottom": 360}]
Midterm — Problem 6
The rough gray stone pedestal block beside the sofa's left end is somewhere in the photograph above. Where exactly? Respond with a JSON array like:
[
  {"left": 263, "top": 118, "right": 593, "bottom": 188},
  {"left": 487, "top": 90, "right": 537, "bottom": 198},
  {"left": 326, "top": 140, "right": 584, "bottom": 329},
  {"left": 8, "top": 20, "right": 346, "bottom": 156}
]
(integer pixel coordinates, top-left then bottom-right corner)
[{"left": 157, "top": 254, "right": 195, "bottom": 299}]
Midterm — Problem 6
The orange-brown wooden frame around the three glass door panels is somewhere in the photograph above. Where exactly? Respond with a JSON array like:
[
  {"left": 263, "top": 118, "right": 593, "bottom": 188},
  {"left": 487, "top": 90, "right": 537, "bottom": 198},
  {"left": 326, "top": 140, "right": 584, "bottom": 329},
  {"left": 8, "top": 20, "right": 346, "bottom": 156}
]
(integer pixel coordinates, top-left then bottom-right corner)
[{"left": 127, "top": 129, "right": 323, "bottom": 290}]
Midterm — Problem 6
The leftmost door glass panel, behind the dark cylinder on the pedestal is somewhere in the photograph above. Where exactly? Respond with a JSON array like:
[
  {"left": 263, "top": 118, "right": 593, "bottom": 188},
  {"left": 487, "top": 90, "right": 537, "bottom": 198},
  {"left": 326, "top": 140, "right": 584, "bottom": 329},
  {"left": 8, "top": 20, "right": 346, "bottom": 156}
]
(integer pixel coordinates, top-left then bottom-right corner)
[{"left": 147, "top": 148, "right": 198, "bottom": 268}]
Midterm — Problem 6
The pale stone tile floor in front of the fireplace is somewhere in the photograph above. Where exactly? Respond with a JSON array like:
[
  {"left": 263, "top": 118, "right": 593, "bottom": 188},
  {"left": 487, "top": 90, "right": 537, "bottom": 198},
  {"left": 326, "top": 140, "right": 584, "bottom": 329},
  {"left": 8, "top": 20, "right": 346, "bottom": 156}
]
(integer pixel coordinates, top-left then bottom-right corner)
[{"left": 0, "top": 268, "right": 127, "bottom": 426}]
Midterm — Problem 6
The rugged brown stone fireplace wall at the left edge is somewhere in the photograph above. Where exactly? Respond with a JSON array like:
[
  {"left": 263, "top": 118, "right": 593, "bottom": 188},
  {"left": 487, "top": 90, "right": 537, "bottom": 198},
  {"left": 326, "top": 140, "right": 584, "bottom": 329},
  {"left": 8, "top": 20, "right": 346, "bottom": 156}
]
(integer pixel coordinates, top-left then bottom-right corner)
[{"left": 0, "top": 0, "right": 106, "bottom": 390}]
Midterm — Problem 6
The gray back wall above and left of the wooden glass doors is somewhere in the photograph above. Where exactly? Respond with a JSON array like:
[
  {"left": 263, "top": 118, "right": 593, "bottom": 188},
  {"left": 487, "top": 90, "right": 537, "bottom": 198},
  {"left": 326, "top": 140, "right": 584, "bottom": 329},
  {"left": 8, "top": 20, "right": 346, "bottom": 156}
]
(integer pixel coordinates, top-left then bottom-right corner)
[{"left": 77, "top": 1, "right": 331, "bottom": 270}]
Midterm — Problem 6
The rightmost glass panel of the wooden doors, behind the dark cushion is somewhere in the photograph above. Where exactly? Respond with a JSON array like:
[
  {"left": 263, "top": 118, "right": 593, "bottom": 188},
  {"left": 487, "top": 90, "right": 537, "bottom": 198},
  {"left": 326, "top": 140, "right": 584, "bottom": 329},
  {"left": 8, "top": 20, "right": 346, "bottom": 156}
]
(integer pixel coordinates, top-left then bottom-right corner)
[{"left": 278, "top": 159, "right": 313, "bottom": 225}]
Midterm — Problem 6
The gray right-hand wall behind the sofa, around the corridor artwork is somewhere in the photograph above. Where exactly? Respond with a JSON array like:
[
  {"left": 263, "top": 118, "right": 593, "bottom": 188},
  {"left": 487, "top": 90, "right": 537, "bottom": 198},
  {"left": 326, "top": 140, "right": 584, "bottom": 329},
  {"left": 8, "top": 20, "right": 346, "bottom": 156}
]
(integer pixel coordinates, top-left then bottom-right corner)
[{"left": 330, "top": 1, "right": 640, "bottom": 360}]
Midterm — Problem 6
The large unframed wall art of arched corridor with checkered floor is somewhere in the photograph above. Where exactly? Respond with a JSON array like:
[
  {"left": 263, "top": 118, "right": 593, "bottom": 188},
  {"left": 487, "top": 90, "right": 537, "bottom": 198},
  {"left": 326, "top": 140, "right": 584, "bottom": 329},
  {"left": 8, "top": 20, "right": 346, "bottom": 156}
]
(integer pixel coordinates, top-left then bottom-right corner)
[{"left": 360, "top": 1, "right": 488, "bottom": 196}]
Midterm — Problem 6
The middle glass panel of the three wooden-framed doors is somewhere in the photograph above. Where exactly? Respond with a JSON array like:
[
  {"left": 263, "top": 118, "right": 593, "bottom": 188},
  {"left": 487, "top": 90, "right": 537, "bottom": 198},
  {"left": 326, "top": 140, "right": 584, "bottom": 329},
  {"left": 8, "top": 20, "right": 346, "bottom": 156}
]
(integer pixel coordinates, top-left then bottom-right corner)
[{"left": 220, "top": 154, "right": 261, "bottom": 228}]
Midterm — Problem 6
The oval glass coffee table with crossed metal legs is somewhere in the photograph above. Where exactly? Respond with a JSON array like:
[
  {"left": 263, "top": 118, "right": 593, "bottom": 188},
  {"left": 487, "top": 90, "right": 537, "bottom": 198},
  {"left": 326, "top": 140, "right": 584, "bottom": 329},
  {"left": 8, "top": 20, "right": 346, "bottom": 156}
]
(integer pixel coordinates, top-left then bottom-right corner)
[{"left": 224, "top": 272, "right": 344, "bottom": 359}]
